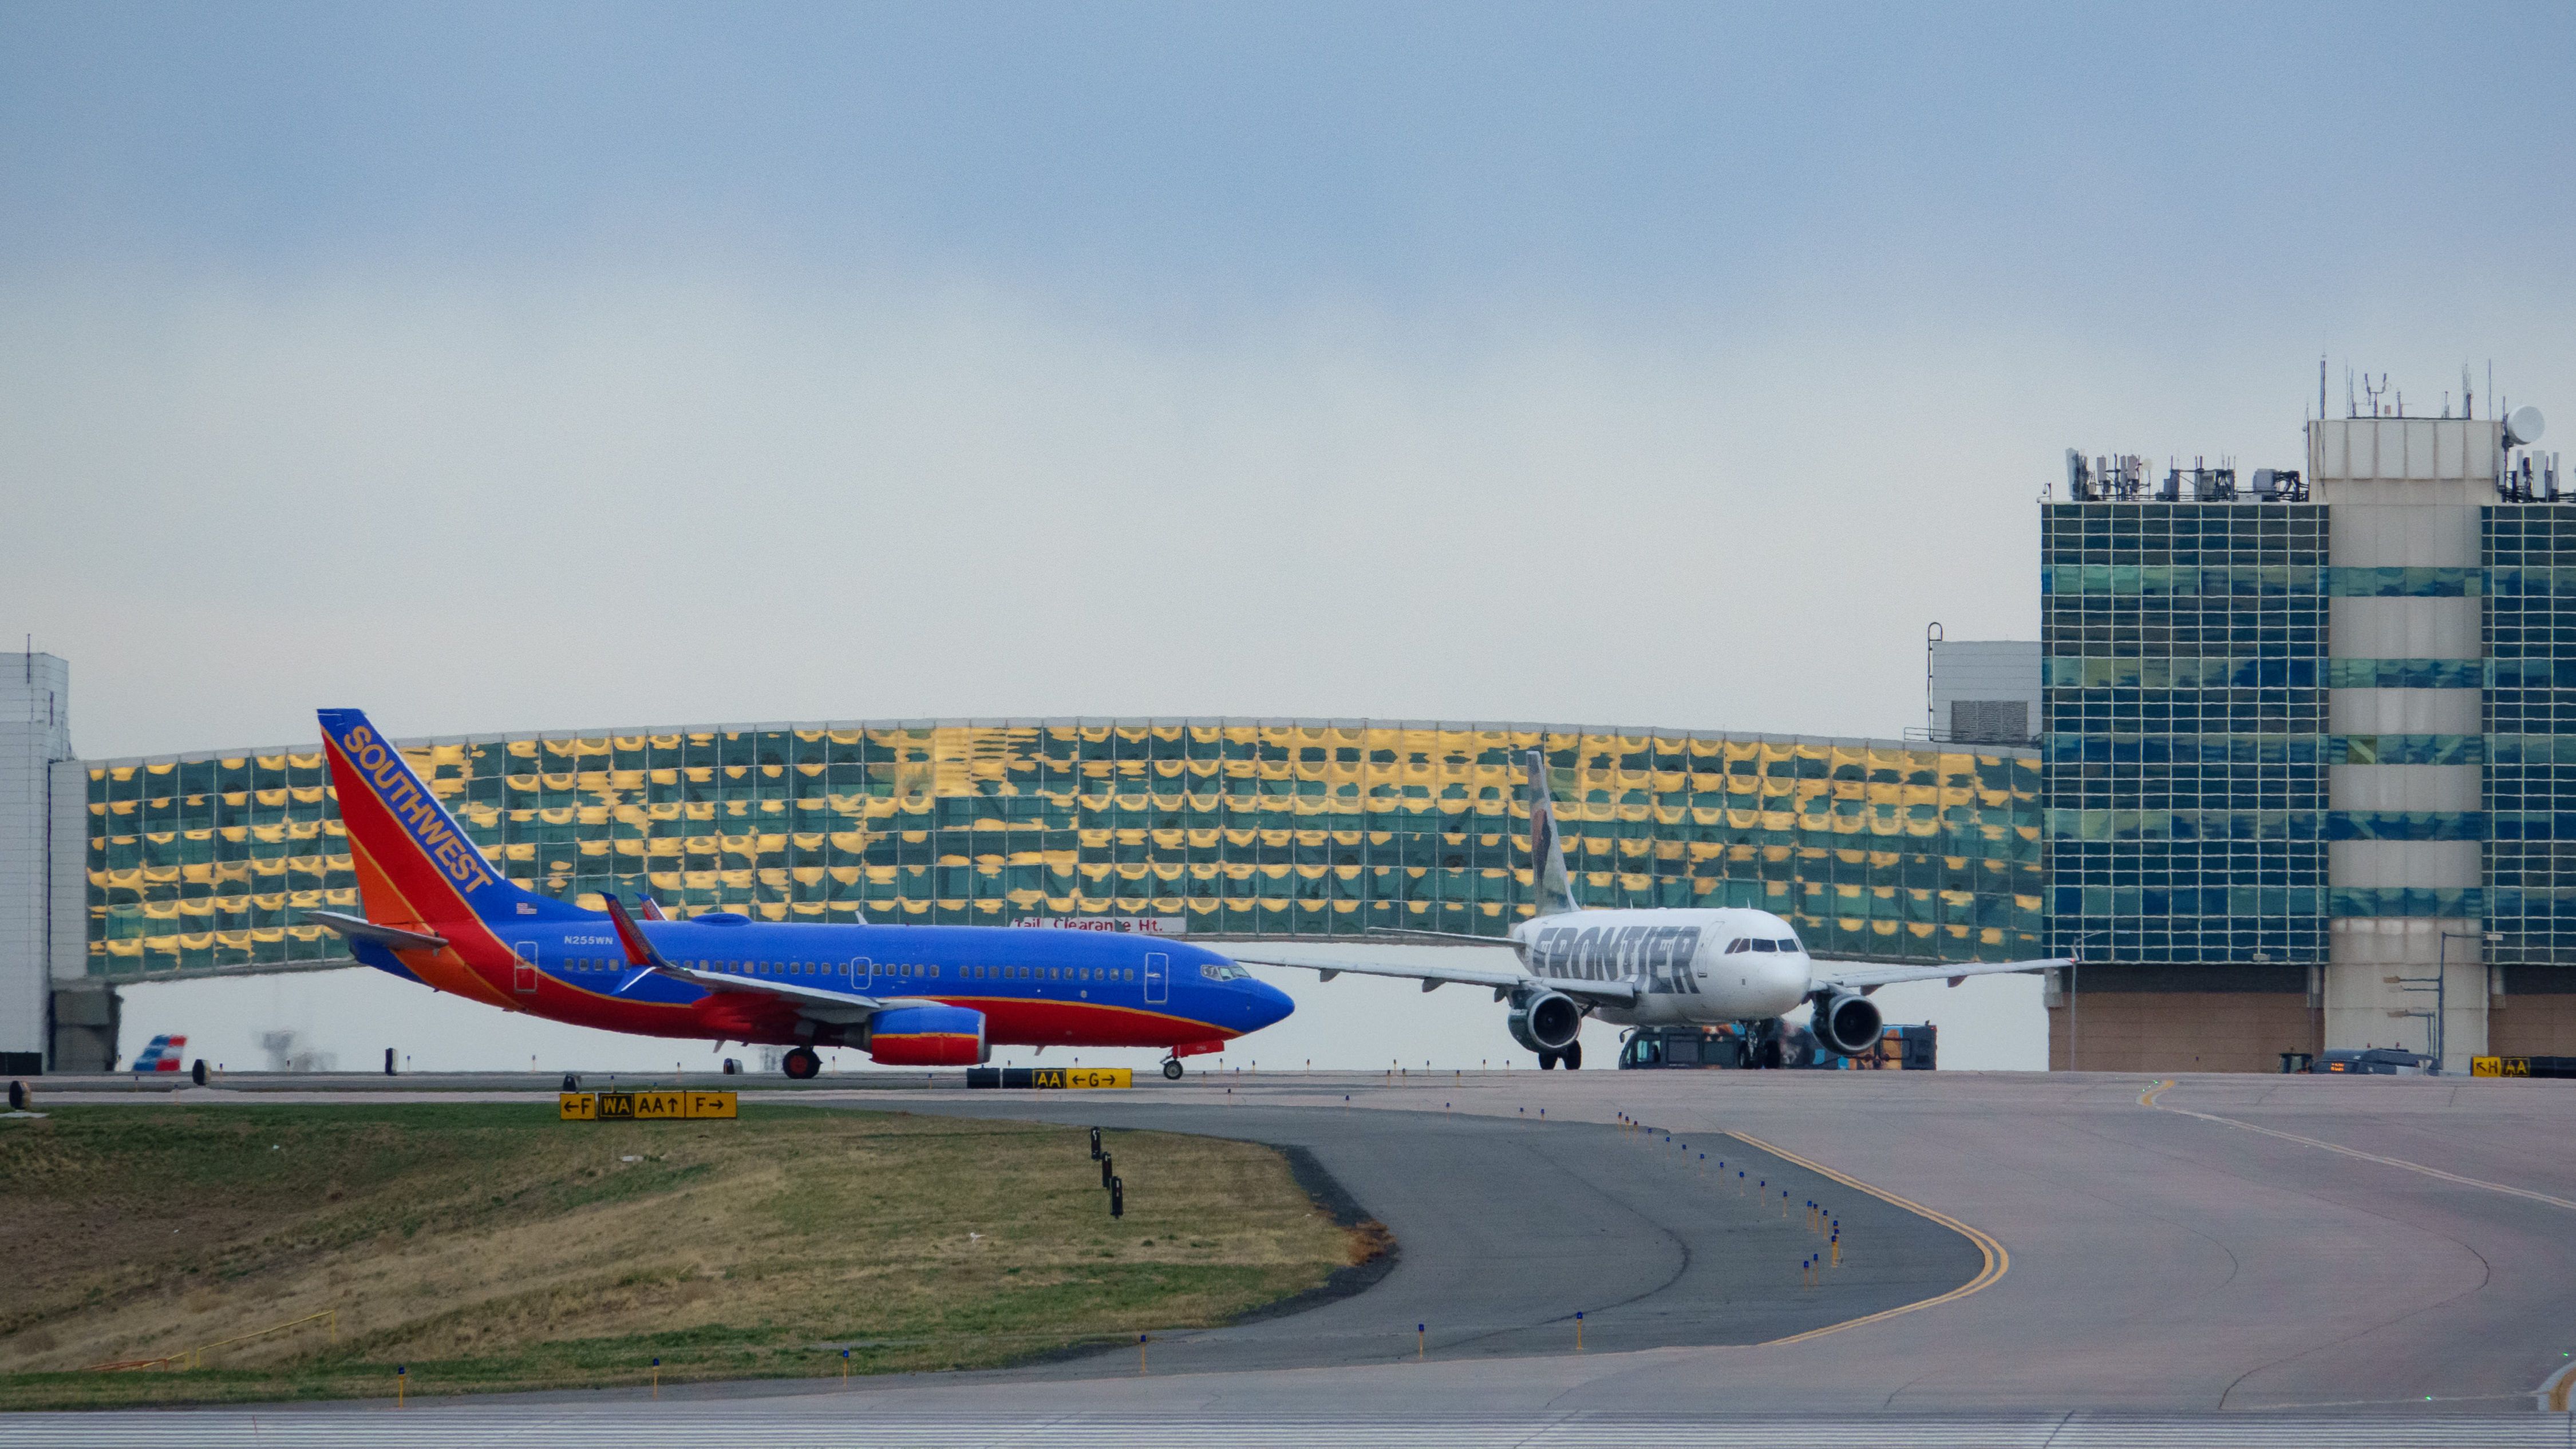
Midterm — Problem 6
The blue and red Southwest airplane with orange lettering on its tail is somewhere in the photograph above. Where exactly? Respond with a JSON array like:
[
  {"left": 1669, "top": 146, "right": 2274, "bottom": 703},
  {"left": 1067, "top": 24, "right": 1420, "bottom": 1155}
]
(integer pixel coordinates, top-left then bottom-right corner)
[{"left": 309, "top": 710, "right": 1296, "bottom": 1078}]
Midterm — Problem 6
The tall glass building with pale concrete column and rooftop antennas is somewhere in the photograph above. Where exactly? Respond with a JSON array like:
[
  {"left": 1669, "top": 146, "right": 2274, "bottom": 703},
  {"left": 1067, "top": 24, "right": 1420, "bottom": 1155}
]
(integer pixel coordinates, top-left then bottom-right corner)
[{"left": 2040, "top": 414, "right": 2576, "bottom": 1071}]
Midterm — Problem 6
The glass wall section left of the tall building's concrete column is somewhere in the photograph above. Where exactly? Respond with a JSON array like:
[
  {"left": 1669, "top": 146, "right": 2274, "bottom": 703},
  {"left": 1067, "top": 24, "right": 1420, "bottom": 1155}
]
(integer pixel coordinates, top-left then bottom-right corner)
[{"left": 2040, "top": 502, "right": 2332, "bottom": 965}]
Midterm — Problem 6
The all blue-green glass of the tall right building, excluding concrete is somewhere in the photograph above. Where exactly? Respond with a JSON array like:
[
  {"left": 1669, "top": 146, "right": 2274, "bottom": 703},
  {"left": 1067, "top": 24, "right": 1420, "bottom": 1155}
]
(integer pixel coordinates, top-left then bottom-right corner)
[{"left": 2040, "top": 502, "right": 2576, "bottom": 965}]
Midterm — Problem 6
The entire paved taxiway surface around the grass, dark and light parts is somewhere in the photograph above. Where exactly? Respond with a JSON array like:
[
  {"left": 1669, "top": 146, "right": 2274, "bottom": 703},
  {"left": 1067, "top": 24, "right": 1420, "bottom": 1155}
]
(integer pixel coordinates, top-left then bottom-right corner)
[{"left": 15, "top": 1071, "right": 2576, "bottom": 1444}]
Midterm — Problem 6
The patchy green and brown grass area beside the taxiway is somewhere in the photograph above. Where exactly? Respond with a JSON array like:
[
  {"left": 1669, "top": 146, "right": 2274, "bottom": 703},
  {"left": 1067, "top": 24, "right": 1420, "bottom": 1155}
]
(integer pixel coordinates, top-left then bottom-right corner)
[{"left": 0, "top": 1104, "right": 1376, "bottom": 1408}]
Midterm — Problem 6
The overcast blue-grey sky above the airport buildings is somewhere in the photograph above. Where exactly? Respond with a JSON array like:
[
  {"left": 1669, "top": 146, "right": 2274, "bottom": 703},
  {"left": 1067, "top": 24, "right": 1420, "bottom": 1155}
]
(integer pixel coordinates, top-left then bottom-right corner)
[{"left": 0, "top": 0, "right": 2576, "bottom": 1075}]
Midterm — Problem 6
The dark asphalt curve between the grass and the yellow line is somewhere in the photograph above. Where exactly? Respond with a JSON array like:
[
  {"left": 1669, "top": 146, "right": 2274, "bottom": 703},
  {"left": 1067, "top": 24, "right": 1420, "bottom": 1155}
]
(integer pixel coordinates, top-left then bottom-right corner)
[{"left": 876, "top": 1094, "right": 1986, "bottom": 1380}]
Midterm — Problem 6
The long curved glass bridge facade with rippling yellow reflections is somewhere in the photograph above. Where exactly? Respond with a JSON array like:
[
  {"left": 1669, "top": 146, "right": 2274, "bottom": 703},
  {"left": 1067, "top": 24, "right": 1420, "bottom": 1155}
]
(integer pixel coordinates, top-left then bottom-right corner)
[{"left": 88, "top": 720, "right": 2043, "bottom": 978}]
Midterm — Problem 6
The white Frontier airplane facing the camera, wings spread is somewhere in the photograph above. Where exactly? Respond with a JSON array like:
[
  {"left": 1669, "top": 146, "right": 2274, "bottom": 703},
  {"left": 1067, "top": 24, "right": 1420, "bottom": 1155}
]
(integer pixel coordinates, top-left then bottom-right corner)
[{"left": 1242, "top": 749, "right": 2069, "bottom": 1071}]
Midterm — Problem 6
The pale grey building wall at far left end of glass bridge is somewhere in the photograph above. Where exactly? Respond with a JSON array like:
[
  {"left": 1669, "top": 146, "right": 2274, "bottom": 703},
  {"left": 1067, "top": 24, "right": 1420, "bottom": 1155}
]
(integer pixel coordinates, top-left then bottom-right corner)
[{"left": 0, "top": 654, "right": 72, "bottom": 1052}]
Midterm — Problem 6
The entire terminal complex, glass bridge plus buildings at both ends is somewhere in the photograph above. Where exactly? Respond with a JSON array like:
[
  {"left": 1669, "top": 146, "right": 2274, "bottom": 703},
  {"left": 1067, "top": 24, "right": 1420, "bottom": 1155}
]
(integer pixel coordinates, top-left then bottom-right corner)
[{"left": 0, "top": 396, "right": 2576, "bottom": 1071}]
